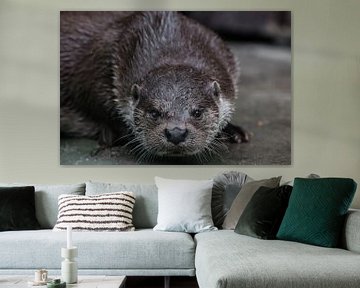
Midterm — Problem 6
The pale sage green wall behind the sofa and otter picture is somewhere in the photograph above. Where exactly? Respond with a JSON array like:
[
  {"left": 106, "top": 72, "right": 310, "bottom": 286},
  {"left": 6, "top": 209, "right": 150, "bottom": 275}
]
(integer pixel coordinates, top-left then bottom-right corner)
[{"left": 0, "top": 0, "right": 360, "bottom": 208}]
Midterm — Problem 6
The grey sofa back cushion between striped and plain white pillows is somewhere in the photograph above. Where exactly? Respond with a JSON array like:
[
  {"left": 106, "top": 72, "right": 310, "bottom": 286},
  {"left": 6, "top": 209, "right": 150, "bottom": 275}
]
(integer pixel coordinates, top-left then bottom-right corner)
[{"left": 86, "top": 181, "right": 158, "bottom": 229}]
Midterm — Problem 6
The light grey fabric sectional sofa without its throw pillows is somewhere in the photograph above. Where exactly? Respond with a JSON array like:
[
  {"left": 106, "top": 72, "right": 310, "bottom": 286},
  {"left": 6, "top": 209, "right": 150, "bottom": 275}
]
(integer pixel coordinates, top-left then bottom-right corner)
[{"left": 0, "top": 182, "right": 360, "bottom": 288}]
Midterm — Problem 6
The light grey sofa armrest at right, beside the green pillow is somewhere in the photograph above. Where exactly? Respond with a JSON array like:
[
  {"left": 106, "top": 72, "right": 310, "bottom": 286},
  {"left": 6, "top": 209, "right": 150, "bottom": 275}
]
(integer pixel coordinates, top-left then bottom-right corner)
[{"left": 343, "top": 210, "right": 360, "bottom": 253}]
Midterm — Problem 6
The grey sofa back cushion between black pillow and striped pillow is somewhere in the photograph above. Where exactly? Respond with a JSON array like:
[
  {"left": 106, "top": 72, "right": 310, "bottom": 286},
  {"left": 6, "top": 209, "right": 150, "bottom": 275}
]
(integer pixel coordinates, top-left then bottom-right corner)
[{"left": 0, "top": 183, "right": 85, "bottom": 229}]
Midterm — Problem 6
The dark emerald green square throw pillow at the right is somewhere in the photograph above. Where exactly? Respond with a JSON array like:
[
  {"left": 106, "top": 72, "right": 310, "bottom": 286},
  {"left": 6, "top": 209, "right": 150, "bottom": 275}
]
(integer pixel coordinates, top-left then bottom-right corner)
[{"left": 277, "top": 178, "right": 356, "bottom": 247}]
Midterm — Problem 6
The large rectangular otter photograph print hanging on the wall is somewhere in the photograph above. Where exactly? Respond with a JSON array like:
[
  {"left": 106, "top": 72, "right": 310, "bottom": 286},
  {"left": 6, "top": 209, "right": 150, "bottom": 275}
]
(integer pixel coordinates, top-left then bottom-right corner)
[{"left": 60, "top": 11, "right": 292, "bottom": 165}]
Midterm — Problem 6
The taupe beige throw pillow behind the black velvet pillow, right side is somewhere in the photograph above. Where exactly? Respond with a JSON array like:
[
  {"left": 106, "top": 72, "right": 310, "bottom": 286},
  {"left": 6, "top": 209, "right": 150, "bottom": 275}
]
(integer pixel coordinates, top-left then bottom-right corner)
[{"left": 222, "top": 176, "right": 281, "bottom": 230}]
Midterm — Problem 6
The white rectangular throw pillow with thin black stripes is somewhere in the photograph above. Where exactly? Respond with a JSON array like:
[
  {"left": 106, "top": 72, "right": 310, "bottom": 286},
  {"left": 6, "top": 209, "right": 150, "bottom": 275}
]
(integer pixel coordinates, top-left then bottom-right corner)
[{"left": 54, "top": 192, "right": 135, "bottom": 231}]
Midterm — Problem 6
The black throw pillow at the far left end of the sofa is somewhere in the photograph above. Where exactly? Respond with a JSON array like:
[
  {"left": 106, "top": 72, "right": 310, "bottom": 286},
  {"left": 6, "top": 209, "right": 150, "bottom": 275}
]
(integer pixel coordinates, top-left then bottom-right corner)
[{"left": 0, "top": 186, "right": 40, "bottom": 231}]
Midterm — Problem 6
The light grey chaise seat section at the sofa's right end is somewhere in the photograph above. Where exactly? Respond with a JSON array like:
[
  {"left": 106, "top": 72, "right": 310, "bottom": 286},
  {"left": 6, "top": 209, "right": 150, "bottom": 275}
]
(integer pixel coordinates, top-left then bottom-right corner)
[{"left": 195, "top": 230, "right": 360, "bottom": 288}]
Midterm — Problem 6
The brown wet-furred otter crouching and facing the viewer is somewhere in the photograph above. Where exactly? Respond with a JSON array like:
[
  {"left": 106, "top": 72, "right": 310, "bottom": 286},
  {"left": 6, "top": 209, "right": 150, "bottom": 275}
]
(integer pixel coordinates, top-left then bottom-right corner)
[{"left": 60, "top": 11, "right": 249, "bottom": 160}]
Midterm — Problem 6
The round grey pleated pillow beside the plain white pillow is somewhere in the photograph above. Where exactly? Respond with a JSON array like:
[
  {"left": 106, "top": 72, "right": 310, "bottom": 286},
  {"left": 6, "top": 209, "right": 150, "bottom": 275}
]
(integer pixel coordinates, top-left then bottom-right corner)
[{"left": 211, "top": 171, "right": 252, "bottom": 228}]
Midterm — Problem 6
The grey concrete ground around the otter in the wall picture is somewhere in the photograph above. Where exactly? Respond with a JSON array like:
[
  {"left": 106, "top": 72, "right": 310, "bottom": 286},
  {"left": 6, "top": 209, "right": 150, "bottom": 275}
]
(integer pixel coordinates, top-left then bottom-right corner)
[{"left": 60, "top": 43, "right": 291, "bottom": 165}]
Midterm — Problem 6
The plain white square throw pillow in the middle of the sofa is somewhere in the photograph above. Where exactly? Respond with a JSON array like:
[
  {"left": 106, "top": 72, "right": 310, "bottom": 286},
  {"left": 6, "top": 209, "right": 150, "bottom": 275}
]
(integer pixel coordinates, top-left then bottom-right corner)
[{"left": 154, "top": 177, "right": 217, "bottom": 233}]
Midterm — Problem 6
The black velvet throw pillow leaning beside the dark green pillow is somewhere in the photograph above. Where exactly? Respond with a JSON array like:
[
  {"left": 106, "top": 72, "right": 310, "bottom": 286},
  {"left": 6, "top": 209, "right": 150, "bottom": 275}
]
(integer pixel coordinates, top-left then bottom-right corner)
[{"left": 235, "top": 185, "right": 292, "bottom": 239}]
